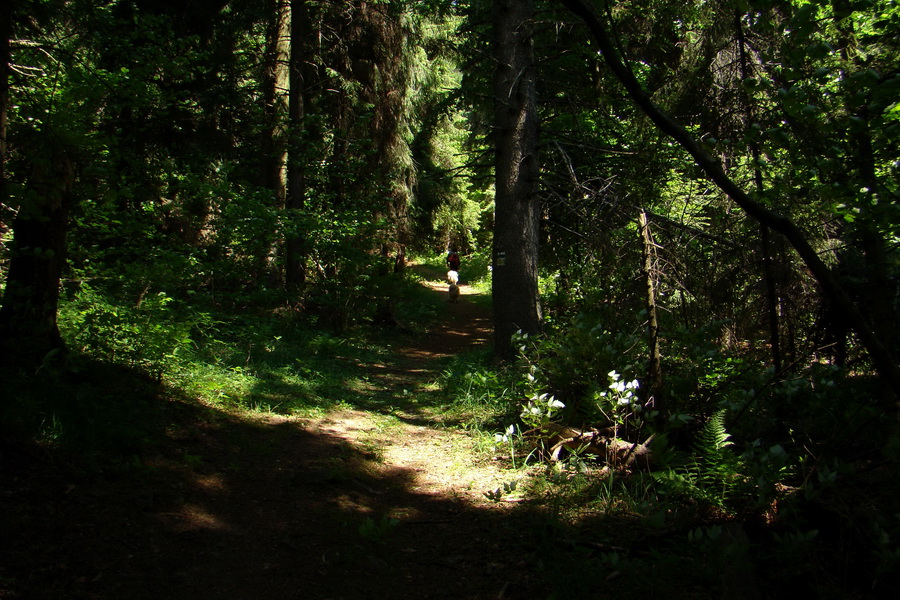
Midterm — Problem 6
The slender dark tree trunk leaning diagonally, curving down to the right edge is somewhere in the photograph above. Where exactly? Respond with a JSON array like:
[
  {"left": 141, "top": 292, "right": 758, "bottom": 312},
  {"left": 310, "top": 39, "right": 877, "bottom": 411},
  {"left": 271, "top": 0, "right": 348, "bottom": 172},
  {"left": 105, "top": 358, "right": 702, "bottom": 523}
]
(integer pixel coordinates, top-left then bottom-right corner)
[{"left": 561, "top": 0, "right": 900, "bottom": 398}]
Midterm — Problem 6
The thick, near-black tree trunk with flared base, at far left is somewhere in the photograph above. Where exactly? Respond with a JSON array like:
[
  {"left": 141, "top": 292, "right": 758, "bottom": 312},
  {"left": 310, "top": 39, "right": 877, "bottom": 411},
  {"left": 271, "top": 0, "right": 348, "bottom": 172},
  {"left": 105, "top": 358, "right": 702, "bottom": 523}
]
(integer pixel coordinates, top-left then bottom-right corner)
[{"left": 0, "top": 144, "right": 75, "bottom": 367}]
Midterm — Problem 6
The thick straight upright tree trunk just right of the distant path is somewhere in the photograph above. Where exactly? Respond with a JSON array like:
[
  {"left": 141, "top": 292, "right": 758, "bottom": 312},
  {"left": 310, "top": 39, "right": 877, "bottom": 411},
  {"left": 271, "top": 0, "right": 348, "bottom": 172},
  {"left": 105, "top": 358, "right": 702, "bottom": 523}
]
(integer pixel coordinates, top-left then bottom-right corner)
[{"left": 493, "top": 0, "right": 541, "bottom": 358}]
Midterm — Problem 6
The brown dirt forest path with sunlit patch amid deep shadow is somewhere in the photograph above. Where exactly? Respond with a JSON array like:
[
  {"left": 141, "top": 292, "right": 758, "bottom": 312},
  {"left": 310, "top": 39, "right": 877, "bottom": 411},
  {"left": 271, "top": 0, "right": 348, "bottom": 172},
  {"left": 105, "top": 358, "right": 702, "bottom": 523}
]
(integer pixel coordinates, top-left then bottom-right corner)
[{"left": 0, "top": 268, "right": 546, "bottom": 600}]
